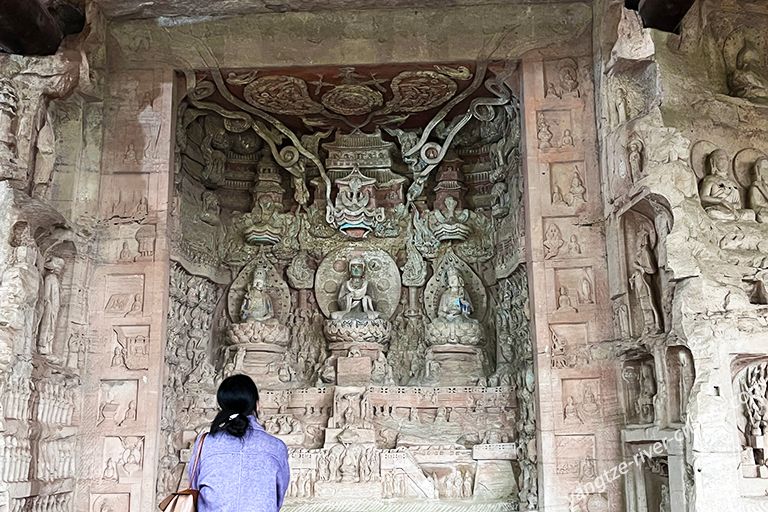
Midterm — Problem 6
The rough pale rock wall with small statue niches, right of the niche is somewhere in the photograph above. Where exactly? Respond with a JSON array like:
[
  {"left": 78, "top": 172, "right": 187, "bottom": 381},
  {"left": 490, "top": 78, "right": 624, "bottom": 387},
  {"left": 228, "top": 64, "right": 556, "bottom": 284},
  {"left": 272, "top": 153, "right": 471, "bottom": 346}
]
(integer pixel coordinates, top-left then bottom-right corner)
[{"left": 595, "top": 0, "right": 768, "bottom": 510}]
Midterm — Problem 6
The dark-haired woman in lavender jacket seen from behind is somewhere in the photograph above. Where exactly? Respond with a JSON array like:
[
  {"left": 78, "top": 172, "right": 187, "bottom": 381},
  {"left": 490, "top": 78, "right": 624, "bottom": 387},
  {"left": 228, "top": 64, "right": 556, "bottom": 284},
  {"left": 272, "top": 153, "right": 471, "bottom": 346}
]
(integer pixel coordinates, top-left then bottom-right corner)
[{"left": 189, "top": 375, "right": 290, "bottom": 512}]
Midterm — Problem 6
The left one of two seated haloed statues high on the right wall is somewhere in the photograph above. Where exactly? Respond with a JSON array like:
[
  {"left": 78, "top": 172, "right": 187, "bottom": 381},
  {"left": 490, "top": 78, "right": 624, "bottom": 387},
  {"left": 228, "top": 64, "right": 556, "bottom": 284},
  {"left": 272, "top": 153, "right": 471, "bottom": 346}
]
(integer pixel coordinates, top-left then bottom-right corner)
[{"left": 699, "top": 149, "right": 751, "bottom": 220}]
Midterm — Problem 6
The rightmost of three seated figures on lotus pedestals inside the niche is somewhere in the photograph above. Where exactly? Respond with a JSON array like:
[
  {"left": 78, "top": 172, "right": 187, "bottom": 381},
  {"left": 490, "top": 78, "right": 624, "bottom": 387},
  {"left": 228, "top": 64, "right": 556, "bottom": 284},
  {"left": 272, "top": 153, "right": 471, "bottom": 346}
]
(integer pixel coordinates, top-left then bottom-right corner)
[{"left": 426, "top": 265, "right": 483, "bottom": 345}]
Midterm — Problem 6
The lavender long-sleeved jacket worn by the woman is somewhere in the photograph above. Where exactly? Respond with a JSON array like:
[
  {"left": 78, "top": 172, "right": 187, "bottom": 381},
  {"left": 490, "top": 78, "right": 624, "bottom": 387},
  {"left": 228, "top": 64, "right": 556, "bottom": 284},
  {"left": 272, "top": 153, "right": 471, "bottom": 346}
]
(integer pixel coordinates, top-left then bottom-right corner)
[{"left": 189, "top": 416, "right": 291, "bottom": 512}]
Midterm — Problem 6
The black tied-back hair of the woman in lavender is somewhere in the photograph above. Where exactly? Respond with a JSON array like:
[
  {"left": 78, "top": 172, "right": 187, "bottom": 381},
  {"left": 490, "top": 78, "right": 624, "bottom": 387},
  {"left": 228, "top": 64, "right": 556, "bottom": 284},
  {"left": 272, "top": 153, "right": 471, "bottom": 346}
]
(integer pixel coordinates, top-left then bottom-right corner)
[{"left": 211, "top": 375, "right": 259, "bottom": 437}]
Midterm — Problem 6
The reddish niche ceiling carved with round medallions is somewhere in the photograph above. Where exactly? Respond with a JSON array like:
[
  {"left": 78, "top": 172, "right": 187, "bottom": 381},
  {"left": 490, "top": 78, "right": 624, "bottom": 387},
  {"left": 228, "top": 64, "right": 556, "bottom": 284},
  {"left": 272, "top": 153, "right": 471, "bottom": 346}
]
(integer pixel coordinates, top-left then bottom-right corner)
[{"left": 194, "top": 62, "right": 508, "bottom": 134}]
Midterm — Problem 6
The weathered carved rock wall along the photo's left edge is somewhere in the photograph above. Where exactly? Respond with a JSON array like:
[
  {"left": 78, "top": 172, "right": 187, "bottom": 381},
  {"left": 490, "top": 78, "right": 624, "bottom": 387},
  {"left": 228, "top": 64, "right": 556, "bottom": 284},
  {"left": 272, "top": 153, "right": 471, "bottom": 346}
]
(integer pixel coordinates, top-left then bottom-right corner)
[{"left": 0, "top": 5, "right": 103, "bottom": 512}]
